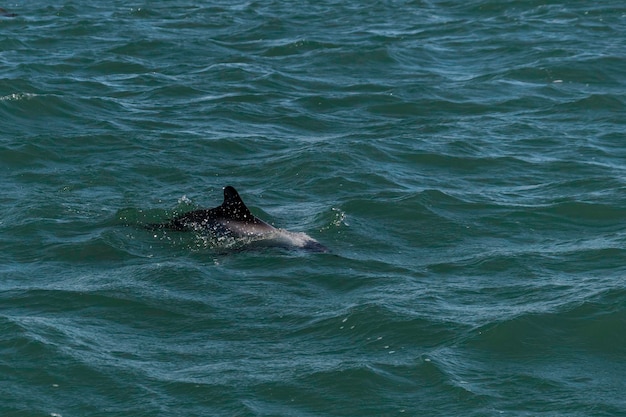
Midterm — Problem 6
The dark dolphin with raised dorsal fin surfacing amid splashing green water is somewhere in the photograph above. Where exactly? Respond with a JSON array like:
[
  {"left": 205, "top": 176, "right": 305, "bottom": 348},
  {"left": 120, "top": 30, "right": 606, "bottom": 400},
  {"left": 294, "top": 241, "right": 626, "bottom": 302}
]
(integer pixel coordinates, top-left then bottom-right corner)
[{"left": 146, "top": 186, "right": 329, "bottom": 252}]
